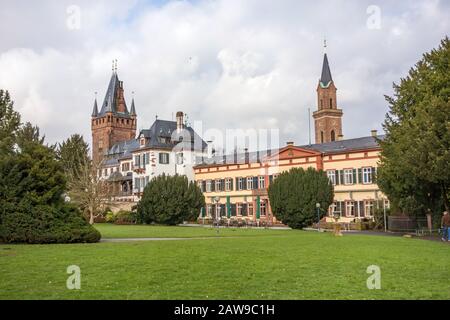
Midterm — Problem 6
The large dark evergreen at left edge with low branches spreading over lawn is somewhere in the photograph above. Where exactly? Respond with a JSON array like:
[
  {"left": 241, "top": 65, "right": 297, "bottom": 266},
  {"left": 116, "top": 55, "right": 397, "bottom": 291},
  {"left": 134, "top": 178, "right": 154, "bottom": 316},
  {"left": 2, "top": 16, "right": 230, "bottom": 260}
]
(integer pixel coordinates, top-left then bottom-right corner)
[{"left": 0, "top": 91, "right": 100, "bottom": 243}]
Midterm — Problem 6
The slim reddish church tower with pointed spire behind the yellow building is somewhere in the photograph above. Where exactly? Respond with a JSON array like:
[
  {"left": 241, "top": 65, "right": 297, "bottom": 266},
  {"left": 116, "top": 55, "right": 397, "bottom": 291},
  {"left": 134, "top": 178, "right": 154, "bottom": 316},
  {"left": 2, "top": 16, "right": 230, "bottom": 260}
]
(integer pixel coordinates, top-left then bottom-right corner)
[{"left": 313, "top": 44, "right": 343, "bottom": 143}]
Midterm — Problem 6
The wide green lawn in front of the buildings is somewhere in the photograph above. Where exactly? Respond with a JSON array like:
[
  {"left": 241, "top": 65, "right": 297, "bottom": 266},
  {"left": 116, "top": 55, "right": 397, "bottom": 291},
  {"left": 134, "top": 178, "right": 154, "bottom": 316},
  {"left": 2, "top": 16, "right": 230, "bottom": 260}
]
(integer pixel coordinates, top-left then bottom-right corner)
[{"left": 0, "top": 225, "right": 450, "bottom": 299}]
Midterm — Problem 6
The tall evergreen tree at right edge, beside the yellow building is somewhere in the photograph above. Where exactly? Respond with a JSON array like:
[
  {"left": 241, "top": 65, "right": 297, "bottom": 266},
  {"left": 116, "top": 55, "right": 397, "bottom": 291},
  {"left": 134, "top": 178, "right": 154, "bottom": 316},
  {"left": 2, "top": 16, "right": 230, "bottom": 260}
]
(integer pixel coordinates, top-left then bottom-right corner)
[{"left": 377, "top": 38, "right": 450, "bottom": 215}]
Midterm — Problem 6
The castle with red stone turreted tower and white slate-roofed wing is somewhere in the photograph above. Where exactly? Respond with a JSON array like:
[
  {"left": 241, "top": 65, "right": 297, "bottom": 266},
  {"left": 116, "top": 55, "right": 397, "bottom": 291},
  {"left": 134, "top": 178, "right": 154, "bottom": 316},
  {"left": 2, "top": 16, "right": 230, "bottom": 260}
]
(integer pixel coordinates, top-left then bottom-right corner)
[{"left": 91, "top": 70, "right": 207, "bottom": 202}]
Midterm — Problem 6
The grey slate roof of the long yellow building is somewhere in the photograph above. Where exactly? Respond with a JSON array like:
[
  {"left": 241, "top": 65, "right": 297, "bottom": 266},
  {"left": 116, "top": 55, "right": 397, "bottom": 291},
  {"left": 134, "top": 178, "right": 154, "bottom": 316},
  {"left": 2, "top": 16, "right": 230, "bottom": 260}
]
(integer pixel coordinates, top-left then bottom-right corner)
[{"left": 196, "top": 135, "right": 385, "bottom": 167}]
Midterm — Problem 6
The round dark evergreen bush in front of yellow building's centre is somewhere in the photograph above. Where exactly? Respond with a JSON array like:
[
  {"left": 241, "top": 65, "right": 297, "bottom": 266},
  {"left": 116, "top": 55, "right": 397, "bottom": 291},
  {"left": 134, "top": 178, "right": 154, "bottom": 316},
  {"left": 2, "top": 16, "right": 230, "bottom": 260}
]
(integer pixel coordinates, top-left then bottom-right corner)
[{"left": 268, "top": 168, "right": 334, "bottom": 229}]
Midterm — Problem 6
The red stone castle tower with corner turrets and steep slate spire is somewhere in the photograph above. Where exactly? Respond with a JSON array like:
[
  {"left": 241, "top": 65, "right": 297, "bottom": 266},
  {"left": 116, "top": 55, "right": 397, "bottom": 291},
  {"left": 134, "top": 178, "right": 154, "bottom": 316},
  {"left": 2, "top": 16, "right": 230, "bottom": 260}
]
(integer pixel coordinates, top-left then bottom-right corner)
[{"left": 91, "top": 62, "right": 137, "bottom": 162}]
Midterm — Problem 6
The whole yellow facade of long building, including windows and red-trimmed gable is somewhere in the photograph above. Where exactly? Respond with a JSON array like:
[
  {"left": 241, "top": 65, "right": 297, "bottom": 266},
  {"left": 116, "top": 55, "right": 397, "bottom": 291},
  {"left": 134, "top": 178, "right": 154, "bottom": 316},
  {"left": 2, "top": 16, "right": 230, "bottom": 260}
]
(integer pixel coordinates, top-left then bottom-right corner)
[{"left": 194, "top": 142, "right": 385, "bottom": 224}]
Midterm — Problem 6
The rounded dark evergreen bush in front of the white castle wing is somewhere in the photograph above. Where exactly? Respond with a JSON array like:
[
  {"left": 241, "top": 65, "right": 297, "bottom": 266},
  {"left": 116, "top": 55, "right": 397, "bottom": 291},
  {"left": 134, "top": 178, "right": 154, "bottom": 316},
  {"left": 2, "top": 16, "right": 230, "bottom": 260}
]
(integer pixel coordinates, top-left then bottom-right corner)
[{"left": 137, "top": 174, "right": 205, "bottom": 225}]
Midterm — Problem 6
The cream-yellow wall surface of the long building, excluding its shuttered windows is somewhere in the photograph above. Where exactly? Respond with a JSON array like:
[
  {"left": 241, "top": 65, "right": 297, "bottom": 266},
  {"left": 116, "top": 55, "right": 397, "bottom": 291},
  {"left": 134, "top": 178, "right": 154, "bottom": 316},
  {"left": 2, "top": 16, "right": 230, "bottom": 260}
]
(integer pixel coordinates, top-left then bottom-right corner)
[{"left": 195, "top": 146, "right": 385, "bottom": 223}]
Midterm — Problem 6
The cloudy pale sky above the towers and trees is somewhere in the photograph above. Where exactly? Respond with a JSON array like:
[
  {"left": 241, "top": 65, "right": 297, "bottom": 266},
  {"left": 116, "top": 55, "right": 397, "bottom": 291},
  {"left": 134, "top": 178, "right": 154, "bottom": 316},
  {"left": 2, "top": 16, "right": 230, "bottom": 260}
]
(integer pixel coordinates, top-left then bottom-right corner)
[{"left": 0, "top": 0, "right": 450, "bottom": 150}]
